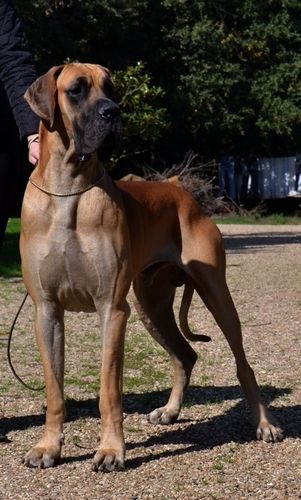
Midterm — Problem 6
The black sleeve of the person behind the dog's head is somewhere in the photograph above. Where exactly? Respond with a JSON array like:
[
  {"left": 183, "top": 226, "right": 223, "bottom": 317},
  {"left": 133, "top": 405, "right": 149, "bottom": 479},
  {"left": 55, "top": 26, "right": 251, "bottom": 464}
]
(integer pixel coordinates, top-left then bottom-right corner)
[{"left": 0, "top": 0, "right": 39, "bottom": 138}]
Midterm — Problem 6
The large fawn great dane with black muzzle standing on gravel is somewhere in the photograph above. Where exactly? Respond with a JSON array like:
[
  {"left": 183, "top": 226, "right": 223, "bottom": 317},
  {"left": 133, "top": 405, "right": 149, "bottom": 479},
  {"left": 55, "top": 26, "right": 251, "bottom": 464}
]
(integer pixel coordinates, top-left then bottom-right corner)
[{"left": 20, "top": 63, "right": 282, "bottom": 471}]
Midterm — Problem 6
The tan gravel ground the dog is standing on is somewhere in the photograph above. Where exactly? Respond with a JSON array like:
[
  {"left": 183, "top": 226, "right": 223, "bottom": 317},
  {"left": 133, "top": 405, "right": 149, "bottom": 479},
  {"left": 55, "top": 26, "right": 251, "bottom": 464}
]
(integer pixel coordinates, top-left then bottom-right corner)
[{"left": 0, "top": 225, "right": 301, "bottom": 500}]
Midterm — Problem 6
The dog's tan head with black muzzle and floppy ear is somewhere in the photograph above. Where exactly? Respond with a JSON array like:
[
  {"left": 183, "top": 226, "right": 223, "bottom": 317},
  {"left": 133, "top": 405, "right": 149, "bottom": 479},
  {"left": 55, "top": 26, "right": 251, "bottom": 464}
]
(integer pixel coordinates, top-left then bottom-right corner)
[{"left": 24, "top": 63, "right": 121, "bottom": 159}]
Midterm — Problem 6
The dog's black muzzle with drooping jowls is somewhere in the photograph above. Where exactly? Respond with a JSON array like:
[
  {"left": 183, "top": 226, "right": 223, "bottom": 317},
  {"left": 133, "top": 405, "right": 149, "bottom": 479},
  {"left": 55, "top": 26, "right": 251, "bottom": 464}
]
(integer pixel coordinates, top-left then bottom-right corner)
[{"left": 74, "top": 99, "right": 121, "bottom": 161}]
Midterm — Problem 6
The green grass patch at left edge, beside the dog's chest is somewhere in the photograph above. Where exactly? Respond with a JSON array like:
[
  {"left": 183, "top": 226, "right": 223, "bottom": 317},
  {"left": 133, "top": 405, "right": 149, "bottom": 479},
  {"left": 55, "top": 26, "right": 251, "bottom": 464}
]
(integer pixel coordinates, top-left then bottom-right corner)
[{"left": 0, "top": 219, "right": 21, "bottom": 278}]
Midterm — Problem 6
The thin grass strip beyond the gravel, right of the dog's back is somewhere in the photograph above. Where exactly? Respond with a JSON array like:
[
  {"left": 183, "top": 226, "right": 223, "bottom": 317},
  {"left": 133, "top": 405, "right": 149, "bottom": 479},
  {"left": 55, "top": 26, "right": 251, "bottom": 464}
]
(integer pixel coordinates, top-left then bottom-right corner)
[{"left": 212, "top": 213, "right": 301, "bottom": 225}]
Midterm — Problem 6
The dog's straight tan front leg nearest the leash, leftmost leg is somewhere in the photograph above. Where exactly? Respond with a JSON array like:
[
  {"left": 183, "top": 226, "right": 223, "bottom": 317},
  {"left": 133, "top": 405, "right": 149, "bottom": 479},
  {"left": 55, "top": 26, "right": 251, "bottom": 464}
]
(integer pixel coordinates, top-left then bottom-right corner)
[{"left": 24, "top": 304, "right": 65, "bottom": 468}]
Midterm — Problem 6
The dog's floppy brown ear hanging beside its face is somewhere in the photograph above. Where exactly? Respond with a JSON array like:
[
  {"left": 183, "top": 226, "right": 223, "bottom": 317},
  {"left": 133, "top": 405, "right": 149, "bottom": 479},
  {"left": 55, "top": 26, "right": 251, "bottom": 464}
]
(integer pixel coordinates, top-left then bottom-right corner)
[{"left": 24, "top": 65, "right": 64, "bottom": 127}]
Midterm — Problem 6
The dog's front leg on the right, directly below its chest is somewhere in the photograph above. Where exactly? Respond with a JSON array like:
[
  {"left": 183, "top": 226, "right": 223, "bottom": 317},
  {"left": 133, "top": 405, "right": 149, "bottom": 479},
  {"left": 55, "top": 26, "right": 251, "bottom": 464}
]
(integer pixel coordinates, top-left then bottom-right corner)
[{"left": 92, "top": 302, "right": 129, "bottom": 472}]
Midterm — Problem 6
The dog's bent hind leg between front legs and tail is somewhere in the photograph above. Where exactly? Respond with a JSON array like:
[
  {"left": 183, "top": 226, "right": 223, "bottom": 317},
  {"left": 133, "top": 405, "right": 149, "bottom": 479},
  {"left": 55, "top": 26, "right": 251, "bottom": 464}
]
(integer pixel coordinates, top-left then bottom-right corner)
[{"left": 133, "top": 269, "right": 197, "bottom": 424}]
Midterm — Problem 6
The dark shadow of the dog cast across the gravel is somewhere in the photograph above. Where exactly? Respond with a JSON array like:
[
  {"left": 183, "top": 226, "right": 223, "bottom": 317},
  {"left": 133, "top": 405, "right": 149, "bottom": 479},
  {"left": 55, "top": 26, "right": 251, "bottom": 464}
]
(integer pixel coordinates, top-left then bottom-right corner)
[{"left": 1, "top": 385, "right": 301, "bottom": 469}]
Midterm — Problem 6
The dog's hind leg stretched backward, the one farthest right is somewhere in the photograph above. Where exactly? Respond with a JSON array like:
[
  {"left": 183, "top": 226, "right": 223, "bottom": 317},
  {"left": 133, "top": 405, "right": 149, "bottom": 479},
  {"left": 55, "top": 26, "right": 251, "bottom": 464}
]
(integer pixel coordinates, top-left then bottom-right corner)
[{"left": 188, "top": 261, "right": 283, "bottom": 442}]
